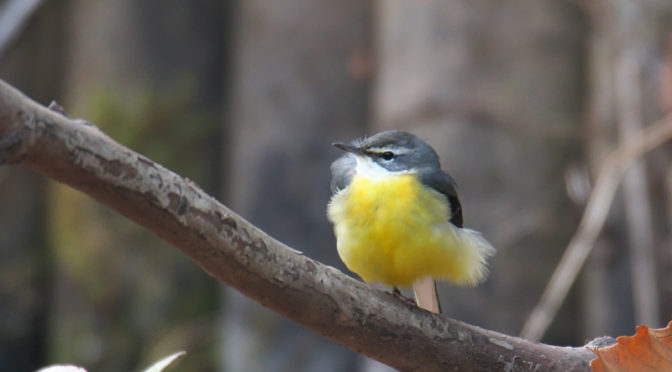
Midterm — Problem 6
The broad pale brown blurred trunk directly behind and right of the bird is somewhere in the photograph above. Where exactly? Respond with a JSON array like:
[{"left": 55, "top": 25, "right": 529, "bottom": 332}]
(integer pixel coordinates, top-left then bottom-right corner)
[{"left": 375, "top": 0, "right": 585, "bottom": 344}]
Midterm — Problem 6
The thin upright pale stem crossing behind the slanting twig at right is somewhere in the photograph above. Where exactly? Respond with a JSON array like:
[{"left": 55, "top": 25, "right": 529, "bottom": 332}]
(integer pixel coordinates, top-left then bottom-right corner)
[{"left": 615, "top": 52, "right": 659, "bottom": 326}]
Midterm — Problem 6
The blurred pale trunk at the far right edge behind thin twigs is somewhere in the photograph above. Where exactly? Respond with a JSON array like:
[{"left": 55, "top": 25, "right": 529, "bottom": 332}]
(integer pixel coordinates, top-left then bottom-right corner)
[{"left": 582, "top": 1, "right": 672, "bottom": 338}]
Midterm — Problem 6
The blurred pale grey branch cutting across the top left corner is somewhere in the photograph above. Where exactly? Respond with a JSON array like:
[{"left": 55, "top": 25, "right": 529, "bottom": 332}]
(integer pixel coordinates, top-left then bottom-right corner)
[{"left": 0, "top": 0, "right": 44, "bottom": 58}]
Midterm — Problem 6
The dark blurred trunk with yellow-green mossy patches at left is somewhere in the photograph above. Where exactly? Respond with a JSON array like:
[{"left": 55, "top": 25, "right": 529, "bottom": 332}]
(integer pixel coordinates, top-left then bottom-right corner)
[{"left": 50, "top": 0, "right": 227, "bottom": 371}]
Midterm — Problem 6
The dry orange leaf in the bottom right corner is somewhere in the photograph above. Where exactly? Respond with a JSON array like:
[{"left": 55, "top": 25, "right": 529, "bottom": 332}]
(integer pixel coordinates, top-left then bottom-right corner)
[{"left": 590, "top": 322, "right": 672, "bottom": 372}]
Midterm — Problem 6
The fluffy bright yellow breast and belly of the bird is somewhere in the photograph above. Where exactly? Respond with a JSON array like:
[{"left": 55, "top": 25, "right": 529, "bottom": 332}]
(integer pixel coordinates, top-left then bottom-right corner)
[{"left": 328, "top": 174, "right": 484, "bottom": 286}]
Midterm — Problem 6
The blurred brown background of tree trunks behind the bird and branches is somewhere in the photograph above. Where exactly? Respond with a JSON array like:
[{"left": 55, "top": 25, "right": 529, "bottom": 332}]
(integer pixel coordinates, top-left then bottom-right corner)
[{"left": 0, "top": 0, "right": 672, "bottom": 372}]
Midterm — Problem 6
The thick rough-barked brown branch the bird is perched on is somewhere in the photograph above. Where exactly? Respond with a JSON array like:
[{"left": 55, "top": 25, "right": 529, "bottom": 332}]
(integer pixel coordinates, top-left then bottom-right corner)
[{"left": 0, "top": 81, "right": 593, "bottom": 371}]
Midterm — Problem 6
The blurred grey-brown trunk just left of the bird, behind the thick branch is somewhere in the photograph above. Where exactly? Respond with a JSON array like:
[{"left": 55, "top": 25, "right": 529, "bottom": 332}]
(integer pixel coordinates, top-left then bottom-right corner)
[{"left": 221, "top": 0, "right": 372, "bottom": 372}]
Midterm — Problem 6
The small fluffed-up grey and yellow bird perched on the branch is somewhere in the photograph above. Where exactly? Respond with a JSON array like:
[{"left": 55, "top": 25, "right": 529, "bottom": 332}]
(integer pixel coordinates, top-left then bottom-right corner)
[{"left": 327, "top": 130, "right": 495, "bottom": 313}]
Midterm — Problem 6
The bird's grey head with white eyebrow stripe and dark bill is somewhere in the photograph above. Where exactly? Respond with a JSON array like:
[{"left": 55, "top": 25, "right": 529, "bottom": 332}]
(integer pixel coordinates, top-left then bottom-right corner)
[{"left": 334, "top": 130, "right": 441, "bottom": 172}]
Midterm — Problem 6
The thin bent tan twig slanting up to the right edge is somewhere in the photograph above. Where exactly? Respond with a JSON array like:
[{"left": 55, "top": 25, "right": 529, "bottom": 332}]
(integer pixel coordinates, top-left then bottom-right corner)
[{"left": 521, "top": 114, "right": 672, "bottom": 341}]
